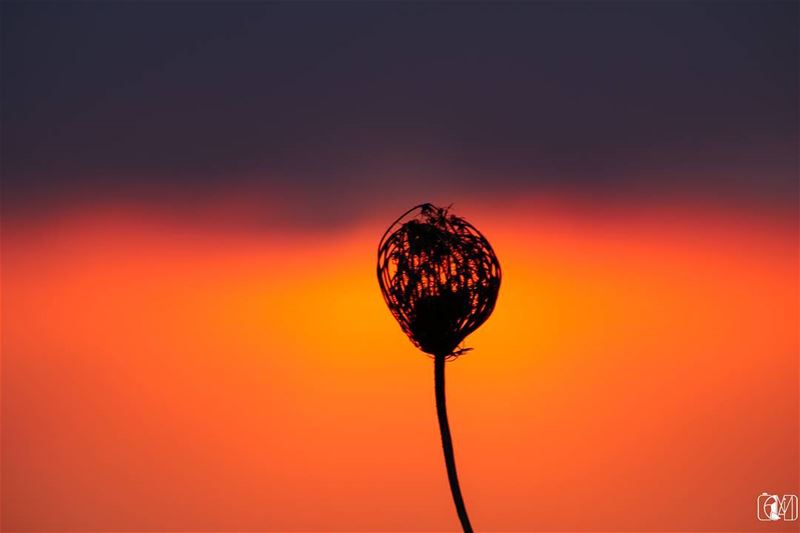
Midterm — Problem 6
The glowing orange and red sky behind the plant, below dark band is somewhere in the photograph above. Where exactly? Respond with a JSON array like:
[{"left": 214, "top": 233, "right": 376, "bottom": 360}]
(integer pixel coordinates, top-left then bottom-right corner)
[{"left": 2, "top": 202, "right": 800, "bottom": 531}]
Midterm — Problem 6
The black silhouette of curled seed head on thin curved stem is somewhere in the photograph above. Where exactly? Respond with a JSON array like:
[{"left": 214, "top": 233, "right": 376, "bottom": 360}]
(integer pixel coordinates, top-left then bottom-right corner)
[{"left": 378, "top": 204, "right": 500, "bottom": 532}]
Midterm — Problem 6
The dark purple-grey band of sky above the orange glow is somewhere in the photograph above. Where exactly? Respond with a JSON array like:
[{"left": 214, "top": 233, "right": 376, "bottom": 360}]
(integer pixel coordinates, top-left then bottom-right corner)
[{"left": 2, "top": 2, "right": 798, "bottom": 227}]
